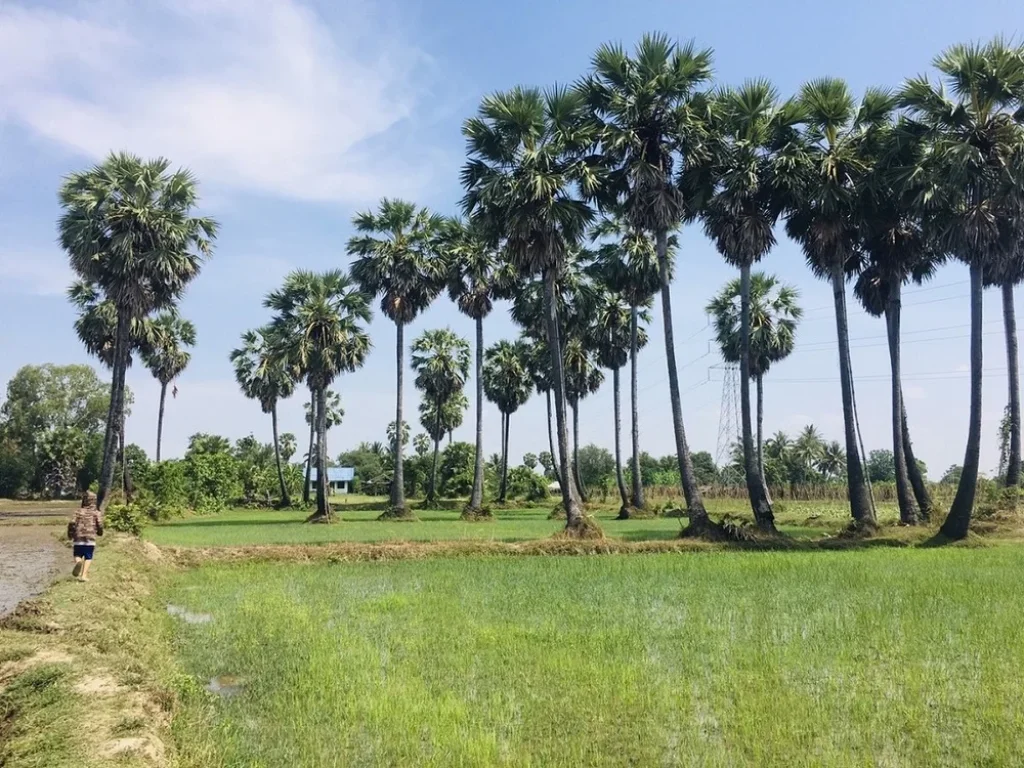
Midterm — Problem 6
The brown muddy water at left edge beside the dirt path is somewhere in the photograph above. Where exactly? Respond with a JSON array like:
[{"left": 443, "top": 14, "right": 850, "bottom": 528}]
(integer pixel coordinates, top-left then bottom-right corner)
[{"left": 0, "top": 525, "right": 66, "bottom": 616}]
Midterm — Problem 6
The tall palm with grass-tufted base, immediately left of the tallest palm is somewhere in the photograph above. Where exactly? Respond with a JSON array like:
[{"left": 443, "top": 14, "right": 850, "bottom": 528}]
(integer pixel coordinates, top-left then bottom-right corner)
[{"left": 462, "top": 87, "right": 599, "bottom": 536}]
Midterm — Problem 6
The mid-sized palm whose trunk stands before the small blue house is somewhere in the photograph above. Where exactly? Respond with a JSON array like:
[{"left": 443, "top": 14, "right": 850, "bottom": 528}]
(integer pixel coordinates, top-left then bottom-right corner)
[{"left": 264, "top": 270, "right": 372, "bottom": 522}]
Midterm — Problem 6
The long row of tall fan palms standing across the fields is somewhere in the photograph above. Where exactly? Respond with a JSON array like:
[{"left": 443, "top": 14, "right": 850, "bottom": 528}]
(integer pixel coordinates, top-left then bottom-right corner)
[{"left": 59, "top": 34, "right": 1024, "bottom": 538}]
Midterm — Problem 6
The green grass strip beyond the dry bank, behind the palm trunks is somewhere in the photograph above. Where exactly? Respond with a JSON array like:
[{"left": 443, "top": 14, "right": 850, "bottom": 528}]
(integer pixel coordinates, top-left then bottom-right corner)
[{"left": 145, "top": 498, "right": 898, "bottom": 547}]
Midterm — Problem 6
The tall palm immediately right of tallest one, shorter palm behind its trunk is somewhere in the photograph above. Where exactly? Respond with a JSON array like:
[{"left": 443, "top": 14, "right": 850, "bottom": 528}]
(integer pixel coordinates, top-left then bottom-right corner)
[{"left": 701, "top": 80, "right": 800, "bottom": 530}]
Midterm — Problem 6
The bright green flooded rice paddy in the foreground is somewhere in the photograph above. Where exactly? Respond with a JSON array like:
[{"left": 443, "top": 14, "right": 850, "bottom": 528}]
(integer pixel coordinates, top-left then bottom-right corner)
[{"left": 165, "top": 546, "right": 1024, "bottom": 766}]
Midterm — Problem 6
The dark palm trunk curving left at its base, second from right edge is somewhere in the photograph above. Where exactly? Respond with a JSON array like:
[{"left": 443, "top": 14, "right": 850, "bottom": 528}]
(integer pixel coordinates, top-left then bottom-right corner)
[{"left": 940, "top": 259, "right": 984, "bottom": 539}]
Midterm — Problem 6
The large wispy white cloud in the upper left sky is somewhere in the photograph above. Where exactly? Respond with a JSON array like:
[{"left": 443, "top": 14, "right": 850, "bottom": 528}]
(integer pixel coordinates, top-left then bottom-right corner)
[{"left": 0, "top": 0, "right": 429, "bottom": 203}]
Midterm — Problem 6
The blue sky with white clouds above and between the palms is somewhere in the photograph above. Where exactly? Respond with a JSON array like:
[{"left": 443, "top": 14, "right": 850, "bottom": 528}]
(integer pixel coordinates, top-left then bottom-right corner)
[{"left": 0, "top": 0, "right": 1024, "bottom": 479}]
